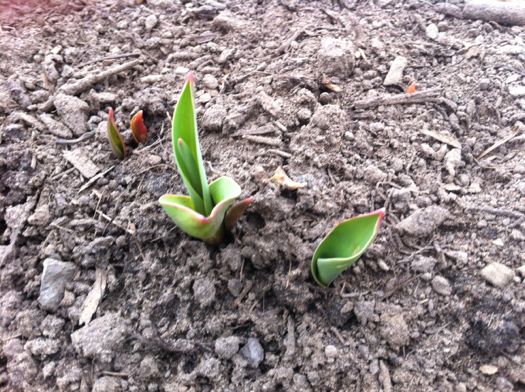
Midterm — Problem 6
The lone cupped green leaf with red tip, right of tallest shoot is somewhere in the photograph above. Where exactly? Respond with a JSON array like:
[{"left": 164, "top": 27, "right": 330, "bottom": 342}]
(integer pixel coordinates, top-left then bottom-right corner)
[{"left": 311, "top": 208, "right": 385, "bottom": 286}]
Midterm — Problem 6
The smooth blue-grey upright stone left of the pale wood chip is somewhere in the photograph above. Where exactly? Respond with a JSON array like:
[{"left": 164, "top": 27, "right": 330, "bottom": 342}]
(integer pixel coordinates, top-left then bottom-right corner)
[{"left": 38, "top": 258, "right": 75, "bottom": 311}]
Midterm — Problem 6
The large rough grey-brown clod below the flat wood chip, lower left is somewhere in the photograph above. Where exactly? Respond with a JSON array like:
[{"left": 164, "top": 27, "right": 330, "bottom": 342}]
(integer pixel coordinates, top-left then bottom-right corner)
[{"left": 71, "top": 313, "right": 129, "bottom": 363}]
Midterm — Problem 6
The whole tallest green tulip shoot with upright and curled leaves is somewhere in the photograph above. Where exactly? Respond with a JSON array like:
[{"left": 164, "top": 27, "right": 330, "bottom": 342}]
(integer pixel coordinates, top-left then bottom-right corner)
[{"left": 159, "top": 74, "right": 252, "bottom": 244}]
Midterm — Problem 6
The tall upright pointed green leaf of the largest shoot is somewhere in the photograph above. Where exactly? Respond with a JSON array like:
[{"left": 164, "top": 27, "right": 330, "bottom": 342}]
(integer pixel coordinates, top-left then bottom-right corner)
[{"left": 171, "top": 73, "right": 214, "bottom": 216}]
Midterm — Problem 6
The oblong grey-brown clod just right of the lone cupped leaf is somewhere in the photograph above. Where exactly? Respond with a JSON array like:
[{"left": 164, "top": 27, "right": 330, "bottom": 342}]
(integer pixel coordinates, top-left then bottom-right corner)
[{"left": 396, "top": 205, "right": 449, "bottom": 237}]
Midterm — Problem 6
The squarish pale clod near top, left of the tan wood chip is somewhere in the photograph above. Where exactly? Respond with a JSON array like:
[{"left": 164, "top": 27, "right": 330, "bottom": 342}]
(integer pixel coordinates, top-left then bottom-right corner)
[{"left": 318, "top": 37, "right": 355, "bottom": 78}]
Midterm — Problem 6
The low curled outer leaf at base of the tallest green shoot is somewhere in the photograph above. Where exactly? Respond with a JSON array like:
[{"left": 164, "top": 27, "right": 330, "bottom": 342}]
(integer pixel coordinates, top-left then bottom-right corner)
[{"left": 159, "top": 177, "right": 241, "bottom": 245}]
